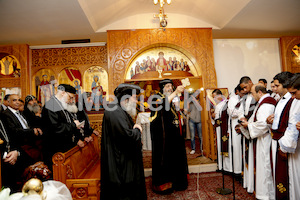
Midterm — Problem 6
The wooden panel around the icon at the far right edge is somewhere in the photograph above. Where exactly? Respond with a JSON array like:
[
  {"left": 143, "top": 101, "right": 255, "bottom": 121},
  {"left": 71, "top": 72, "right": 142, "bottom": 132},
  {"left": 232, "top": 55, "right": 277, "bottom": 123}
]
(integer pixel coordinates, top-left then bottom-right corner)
[{"left": 280, "top": 36, "right": 300, "bottom": 73}]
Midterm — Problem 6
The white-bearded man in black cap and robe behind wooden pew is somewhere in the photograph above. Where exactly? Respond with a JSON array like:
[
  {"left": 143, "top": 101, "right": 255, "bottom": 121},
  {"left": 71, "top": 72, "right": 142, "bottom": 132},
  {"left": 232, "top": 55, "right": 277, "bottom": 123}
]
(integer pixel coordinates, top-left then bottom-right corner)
[{"left": 42, "top": 84, "right": 83, "bottom": 168}]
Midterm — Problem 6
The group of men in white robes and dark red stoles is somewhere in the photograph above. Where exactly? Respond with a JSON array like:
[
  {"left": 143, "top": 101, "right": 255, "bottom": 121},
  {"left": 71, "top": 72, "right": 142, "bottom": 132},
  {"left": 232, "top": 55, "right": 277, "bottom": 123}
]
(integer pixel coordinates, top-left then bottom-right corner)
[{"left": 210, "top": 72, "right": 300, "bottom": 200}]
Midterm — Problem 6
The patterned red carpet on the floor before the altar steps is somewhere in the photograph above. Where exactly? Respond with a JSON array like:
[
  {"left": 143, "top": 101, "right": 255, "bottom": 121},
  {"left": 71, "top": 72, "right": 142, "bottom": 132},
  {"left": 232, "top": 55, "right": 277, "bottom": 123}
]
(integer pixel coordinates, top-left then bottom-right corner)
[{"left": 146, "top": 172, "right": 255, "bottom": 200}]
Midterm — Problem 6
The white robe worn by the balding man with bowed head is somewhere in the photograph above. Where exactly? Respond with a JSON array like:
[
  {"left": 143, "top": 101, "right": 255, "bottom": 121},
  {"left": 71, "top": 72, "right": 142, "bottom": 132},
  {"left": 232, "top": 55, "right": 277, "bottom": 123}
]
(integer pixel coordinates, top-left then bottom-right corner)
[{"left": 248, "top": 94, "right": 275, "bottom": 200}]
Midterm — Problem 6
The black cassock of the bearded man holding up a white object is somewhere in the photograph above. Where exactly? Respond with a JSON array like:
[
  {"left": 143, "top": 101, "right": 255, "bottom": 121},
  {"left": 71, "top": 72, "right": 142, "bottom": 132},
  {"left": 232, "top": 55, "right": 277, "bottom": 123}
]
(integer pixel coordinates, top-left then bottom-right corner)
[{"left": 150, "top": 93, "right": 188, "bottom": 192}]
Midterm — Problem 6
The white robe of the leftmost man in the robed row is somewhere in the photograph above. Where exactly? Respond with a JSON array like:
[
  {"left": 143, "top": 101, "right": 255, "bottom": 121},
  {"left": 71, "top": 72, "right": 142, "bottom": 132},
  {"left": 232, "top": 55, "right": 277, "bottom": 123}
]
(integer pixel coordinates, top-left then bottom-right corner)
[{"left": 215, "top": 100, "right": 227, "bottom": 170}]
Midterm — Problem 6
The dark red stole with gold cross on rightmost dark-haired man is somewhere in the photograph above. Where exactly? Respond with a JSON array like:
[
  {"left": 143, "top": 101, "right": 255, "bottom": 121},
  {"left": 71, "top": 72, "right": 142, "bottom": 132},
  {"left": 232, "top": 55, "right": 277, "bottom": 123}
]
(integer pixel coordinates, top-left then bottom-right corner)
[{"left": 271, "top": 98, "right": 294, "bottom": 200}]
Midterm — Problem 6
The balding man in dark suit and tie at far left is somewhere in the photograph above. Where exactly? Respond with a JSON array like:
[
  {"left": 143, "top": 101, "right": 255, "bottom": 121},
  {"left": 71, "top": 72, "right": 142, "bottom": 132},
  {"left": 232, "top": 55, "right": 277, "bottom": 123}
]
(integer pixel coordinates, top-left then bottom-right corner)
[{"left": 0, "top": 94, "right": 42, "bottom": 191}]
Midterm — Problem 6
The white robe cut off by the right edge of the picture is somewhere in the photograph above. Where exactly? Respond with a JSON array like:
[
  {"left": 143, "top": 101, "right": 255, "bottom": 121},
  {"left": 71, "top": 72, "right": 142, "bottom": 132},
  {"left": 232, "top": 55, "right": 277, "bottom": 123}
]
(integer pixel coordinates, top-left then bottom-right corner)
[{"left": 278, "top": 99, "right": 300, "bottom": 200}]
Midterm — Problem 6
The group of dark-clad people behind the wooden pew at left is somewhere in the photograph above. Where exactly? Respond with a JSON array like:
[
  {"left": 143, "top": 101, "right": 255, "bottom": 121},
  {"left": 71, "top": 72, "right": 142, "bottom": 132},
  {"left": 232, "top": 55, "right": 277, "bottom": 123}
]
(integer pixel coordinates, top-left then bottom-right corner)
[{"left": 0, "top": 84, "right": 99, "bottom": 192}]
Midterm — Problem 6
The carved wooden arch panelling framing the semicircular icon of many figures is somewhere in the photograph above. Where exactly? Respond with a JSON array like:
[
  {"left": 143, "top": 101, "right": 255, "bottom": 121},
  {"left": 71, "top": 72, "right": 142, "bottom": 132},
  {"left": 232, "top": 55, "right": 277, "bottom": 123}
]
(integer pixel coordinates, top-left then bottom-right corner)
[{"left": 107, "top": 28, "right": 217, "bottom": 159}]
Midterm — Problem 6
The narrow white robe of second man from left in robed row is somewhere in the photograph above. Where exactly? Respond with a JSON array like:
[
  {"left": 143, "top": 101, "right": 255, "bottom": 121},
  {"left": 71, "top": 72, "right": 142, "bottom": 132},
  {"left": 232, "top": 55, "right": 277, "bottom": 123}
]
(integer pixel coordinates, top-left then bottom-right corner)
[{"left": 227, "top": 95, "right": 243, "bottom": 174}]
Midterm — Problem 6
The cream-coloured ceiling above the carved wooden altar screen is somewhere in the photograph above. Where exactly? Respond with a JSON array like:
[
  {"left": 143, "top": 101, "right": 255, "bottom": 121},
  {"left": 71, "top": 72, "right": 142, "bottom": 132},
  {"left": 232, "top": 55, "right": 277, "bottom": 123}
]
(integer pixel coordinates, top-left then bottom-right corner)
[{"left": 0, "top": 0, "right": 300, "bottom": 45}]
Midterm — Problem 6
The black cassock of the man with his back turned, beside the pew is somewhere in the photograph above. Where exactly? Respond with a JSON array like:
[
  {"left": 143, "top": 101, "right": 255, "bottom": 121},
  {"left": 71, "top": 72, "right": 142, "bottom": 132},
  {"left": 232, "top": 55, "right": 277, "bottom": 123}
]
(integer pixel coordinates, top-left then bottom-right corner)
[{"left": 101, "top": 104, "right": 147, "bottom": 200}]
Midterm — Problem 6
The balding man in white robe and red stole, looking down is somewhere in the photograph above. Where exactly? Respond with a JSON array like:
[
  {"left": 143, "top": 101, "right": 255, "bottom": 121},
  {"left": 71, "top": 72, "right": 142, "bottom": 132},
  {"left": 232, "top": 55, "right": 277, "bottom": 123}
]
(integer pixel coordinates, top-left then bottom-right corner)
[{"left": 241, "top": 83, "right": 276, "bottom": 199}]
